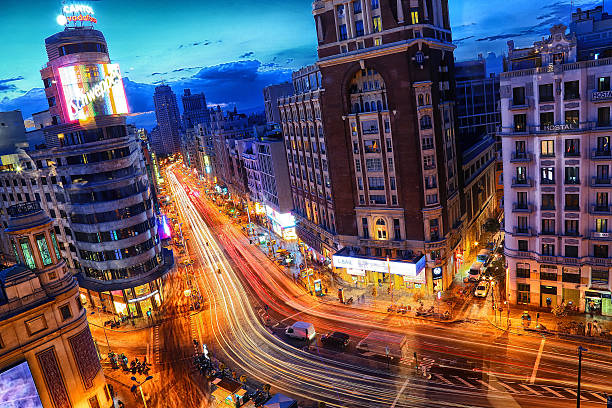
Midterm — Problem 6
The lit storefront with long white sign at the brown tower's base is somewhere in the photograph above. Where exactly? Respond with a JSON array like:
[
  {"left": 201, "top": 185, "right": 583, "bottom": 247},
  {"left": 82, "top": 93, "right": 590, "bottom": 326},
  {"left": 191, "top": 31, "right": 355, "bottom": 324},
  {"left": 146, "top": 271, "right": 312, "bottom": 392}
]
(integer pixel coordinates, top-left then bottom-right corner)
[{"left": 332, "top": 248, "right": 427, "bottom": 290}]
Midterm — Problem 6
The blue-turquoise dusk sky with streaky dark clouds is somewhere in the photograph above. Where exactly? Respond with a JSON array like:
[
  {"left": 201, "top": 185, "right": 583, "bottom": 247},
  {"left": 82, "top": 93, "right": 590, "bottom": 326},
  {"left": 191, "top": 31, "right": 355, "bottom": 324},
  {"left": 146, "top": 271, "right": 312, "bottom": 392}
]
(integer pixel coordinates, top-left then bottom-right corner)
[{"left": 0, "top": 0, "right": 601, "bottom": 127}]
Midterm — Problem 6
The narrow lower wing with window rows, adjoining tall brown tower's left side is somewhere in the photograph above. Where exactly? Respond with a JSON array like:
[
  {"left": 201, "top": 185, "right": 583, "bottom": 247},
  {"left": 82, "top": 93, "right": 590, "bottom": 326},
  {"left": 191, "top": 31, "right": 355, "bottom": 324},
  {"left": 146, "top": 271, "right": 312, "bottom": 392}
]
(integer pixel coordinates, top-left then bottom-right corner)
[{"left": 278, "top": 65, "right": 340, "bottom": 263}]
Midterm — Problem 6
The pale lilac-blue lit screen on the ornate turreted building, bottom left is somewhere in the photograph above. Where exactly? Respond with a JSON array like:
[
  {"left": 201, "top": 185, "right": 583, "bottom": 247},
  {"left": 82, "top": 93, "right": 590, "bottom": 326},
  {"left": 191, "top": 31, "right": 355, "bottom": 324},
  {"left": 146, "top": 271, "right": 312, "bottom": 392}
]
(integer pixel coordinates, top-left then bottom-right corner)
[{"left": 0, "top": 361, "right": 42, "bottom": 408}]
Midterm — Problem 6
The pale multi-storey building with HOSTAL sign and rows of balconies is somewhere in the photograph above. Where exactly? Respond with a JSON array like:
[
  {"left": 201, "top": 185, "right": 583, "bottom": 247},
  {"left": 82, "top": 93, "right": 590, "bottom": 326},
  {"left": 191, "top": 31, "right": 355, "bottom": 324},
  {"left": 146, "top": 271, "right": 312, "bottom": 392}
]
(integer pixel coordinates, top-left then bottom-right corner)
[{"left": 500, "top": 25, "right": 612, "bottom": 315}]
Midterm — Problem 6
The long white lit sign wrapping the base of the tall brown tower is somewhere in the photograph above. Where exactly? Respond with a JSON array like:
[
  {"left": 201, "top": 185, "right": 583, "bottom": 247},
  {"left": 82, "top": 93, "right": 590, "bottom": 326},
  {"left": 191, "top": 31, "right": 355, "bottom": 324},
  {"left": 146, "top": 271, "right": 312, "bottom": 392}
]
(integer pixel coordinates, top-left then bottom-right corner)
[{"left": 332, "top": 255, "right": 425, "bottom": 283}]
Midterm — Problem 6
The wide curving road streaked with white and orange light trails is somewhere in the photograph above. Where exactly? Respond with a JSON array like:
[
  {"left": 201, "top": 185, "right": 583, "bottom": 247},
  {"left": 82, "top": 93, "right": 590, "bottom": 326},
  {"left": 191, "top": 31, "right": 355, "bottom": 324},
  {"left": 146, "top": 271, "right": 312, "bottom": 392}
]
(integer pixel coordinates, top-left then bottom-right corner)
[{"left": 167, "top": 164, "right": 612, "bottom": 407}]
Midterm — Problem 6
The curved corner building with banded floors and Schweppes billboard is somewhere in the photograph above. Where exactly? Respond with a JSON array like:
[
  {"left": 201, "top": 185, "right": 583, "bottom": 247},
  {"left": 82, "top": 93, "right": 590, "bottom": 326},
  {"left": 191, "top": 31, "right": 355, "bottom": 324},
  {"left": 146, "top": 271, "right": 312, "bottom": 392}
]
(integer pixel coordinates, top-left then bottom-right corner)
[{"left": 37, "top": 27, "right": 173, "bottom": 316}]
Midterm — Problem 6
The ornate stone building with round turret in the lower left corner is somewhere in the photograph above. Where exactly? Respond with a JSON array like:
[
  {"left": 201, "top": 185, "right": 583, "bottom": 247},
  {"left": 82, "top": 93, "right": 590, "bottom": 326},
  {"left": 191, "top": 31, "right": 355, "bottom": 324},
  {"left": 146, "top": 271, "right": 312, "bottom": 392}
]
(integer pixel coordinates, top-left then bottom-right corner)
[{"left": 0, "top": 201, "right": 113, "bottom": 407}]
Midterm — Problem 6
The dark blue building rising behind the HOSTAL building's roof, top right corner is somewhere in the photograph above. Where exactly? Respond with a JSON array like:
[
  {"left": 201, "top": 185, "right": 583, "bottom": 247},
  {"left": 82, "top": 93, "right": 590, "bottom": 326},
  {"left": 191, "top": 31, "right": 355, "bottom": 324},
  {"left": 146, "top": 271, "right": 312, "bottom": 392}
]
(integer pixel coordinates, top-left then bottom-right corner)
[{"left": 570, "top": 5, "right": 612, "bottom": 60}]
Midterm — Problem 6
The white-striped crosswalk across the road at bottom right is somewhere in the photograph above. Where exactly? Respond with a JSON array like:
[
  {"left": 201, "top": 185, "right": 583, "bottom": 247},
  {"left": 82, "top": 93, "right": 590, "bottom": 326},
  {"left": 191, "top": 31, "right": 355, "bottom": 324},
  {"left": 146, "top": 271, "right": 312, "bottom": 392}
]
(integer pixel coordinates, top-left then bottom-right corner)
[{"left": 430, "top": 373, "right": 607, "bottom": 403}]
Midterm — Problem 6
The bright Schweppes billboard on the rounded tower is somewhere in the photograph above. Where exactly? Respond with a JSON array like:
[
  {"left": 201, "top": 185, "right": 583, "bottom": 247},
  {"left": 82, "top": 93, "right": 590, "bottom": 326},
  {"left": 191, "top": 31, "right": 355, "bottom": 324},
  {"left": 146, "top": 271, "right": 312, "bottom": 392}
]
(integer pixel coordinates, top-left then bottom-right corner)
[{"left": 59, "top": 64, "right": 128, "bottom": 122}]
